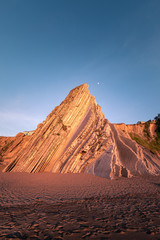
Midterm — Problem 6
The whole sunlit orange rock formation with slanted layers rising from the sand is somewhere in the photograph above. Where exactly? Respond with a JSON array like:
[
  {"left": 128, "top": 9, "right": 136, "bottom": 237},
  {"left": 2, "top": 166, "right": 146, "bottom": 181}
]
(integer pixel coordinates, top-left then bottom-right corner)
[{"left": 0, "top": 84, "right": 160, "bottom": 178}]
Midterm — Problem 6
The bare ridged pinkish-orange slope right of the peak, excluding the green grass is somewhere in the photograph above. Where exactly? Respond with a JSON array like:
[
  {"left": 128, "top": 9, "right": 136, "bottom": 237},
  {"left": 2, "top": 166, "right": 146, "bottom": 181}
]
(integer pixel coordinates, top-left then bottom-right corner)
[{"left": 110, "top": 124, "right": 160, "bottom": 177}]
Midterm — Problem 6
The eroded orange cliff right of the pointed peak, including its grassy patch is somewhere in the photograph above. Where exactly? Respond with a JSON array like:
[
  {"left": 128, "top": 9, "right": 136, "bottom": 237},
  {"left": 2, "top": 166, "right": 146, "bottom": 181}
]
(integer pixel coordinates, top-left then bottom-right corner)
[{"left": 111, "top": 124, "right": 160, "bottom": 176}]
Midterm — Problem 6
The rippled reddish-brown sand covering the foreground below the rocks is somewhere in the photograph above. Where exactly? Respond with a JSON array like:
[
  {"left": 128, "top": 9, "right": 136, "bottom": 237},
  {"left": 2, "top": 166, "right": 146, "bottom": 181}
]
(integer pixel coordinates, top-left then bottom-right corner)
[{"left": 0, "top": 173, "right": 160, "bottom": 240}]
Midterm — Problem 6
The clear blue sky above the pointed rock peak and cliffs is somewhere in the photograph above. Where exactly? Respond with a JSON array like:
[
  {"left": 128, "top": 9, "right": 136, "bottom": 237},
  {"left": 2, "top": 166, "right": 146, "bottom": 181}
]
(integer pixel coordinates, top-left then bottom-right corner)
[{"left": 0, "top": 0, "right": 160, "bottom": 136}]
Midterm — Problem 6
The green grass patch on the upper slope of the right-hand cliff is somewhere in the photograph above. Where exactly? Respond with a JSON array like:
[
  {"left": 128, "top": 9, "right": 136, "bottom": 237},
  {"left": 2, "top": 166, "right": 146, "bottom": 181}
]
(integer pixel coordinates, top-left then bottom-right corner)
[{"left": 129, "top": 133, "right": 160, "bottom": 154}]
